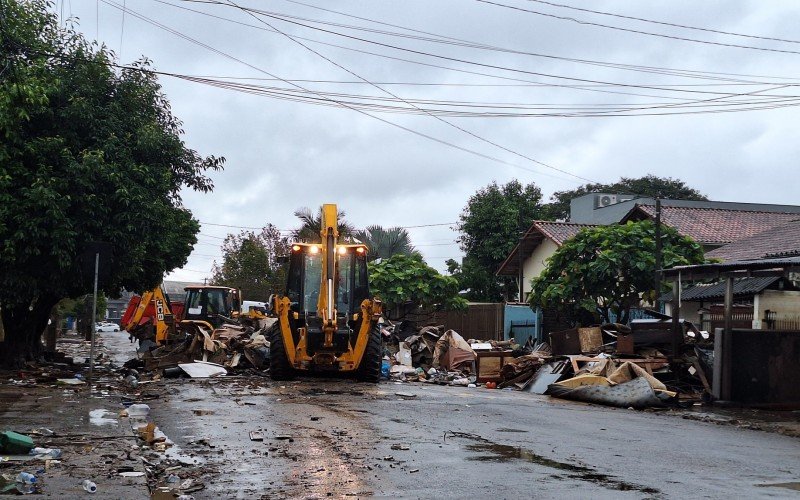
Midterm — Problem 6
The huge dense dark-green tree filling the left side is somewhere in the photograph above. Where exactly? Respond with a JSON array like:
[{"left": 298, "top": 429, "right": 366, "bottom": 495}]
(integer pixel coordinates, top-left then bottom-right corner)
[{"left": 0, "top": 0, "right": 224, "bottom": 366}]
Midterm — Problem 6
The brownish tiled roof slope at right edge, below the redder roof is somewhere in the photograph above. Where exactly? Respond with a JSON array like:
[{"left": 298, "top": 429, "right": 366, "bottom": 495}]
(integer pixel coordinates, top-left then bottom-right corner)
[{"left": 706, "top": 221, "right": 800, "bottom": 262}]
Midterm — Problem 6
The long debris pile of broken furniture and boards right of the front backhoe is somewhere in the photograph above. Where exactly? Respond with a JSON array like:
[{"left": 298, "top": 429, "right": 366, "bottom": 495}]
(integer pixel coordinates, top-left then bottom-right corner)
[{"left": 382, "top": 318, "right": 713, "bottom": 408}]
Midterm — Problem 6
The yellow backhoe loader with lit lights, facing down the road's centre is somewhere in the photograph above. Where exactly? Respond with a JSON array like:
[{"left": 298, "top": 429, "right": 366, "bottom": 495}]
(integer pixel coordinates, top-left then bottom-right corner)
[{"left": 268, "top": 204, "right": 383, "bottom": 382}]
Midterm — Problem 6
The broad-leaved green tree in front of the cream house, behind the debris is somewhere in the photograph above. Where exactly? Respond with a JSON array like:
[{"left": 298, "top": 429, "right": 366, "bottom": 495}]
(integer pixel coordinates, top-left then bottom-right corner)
[{"left": 530, "top": 221, "right": 704, "bottom": 323}]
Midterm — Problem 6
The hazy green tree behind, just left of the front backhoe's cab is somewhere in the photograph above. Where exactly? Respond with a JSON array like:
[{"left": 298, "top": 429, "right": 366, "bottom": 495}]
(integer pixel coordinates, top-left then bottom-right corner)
[{"left": 211, "top": 224, "right": 289, "bottom": 302}]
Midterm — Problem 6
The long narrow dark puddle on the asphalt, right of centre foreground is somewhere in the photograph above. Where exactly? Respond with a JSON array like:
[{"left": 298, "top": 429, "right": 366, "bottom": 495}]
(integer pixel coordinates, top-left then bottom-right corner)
[{"left": 449, "top": 431, "right": 660, "bottom": 494}]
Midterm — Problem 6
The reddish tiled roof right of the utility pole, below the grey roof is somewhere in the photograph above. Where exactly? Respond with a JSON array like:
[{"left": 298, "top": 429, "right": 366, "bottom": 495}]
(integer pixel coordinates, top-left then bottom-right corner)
[{"left": 622, "top": 205, "right": 798, "bottom": 245}]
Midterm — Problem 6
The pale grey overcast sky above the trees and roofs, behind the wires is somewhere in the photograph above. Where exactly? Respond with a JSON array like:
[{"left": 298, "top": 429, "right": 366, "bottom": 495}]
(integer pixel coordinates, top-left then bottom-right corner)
[{"left": 54, "top": 0, "right": 800, "bottom": 281}]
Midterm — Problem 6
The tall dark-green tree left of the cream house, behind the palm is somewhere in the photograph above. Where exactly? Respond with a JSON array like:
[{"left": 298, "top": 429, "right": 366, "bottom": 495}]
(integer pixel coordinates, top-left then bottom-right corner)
[{"left": 448, "top": 180, "right": 544, "bottom": 302}]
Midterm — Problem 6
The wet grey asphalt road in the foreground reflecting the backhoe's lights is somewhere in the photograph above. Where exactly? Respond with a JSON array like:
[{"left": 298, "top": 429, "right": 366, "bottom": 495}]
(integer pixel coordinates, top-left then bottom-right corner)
[{"left": 148, "top": 377, "right": 800, "bottom": 498}]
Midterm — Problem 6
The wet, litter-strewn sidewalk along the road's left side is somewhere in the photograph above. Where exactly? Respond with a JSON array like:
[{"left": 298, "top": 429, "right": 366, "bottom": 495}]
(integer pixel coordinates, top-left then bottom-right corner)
[{"left": 0, "top": 333, "right": 150, "bottom": 499}]
